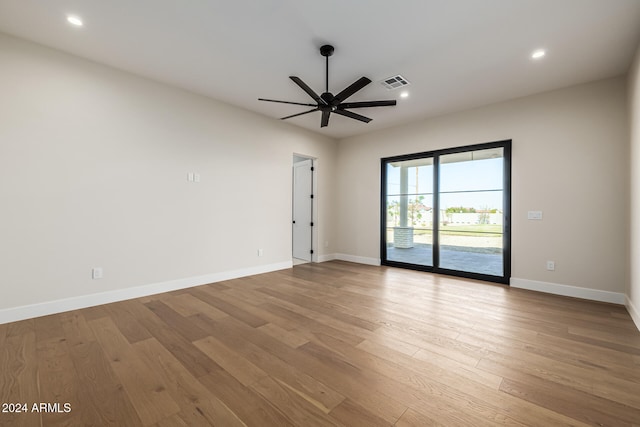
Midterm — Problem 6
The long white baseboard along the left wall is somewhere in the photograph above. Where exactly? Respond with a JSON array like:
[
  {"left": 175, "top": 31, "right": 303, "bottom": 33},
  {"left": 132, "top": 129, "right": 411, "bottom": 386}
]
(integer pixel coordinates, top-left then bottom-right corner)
[{"left": 0, "top": 261, "right": 293, "bottom": 324}]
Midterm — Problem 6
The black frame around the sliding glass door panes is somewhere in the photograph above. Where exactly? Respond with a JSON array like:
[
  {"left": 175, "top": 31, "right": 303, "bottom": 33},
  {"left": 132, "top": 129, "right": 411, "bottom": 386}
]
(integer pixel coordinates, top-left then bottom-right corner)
[{"left": 380, "top": 139, "right": 511, "bottom": 285}]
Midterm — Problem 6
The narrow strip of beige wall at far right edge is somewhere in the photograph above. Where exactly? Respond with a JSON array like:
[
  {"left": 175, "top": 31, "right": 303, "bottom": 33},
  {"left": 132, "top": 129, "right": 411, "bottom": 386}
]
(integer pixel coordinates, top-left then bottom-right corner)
[{"left": 627, "top": 42, "right": 640, "bottom": 328}]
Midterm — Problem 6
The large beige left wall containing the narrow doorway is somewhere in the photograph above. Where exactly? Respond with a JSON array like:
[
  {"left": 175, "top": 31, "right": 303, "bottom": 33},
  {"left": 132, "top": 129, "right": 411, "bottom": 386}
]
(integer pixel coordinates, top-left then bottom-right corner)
[{"left": 0, "top": 35, "right": 337, "bottom": 310}]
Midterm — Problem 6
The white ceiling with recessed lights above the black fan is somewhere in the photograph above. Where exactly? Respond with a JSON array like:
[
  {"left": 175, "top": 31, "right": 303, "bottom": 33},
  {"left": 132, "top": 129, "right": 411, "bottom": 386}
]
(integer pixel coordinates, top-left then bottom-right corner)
[{"left": 0, "top": 0, "right": 640, "bottom": 138}]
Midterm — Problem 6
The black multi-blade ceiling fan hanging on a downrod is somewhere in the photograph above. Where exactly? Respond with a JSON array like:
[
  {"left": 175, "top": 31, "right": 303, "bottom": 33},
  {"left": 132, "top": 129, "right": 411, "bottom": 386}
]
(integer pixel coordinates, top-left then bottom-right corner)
[{"left": 258, "top": 45, "right": 396, "bottom": 127}]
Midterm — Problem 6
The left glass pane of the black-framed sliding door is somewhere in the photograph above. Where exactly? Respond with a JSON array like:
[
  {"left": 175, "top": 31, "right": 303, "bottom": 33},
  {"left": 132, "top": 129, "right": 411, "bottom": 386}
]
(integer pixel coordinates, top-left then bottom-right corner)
[{"left": 384, "top": 157, "right": 433, "bottom": 266}]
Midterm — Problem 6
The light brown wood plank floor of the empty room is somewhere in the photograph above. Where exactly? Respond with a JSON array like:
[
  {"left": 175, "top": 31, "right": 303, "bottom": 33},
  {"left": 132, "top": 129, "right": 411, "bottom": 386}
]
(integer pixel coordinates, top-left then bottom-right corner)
[{"left": 0, "top": 261, "right": 640, "bottom": 427}]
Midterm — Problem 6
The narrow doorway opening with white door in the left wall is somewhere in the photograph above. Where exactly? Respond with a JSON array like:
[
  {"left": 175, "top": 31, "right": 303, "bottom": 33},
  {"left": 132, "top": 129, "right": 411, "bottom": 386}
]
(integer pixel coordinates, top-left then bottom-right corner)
[{"left": 291, "top": 154, "right": 318, "bottom": 266}]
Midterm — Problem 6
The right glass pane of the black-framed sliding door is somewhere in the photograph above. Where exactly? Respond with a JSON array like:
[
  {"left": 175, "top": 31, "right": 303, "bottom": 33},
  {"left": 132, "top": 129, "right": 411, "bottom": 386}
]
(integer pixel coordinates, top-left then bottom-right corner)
[{"left": 438, "top": 147, "right": 505, "bottom": 276}]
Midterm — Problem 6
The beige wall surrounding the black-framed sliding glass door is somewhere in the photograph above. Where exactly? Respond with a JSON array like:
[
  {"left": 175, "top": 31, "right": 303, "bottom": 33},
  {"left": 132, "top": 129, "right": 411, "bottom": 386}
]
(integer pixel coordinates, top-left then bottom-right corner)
[{"left": 338, "top": 77, "right": 628, "bottom": 293}]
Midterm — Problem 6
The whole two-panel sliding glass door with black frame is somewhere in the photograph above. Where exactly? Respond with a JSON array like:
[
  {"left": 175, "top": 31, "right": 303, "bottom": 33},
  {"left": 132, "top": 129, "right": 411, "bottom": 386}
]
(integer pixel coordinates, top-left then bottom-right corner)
[{"left": 381, "top": 141, "right": 511, "bottom": 283}]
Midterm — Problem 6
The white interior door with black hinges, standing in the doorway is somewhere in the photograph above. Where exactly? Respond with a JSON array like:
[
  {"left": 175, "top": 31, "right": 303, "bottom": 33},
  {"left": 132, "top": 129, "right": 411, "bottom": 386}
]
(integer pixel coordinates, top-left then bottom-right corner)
[{"left": 293, "top": 159, "right": 313, "bottom": 261}]
